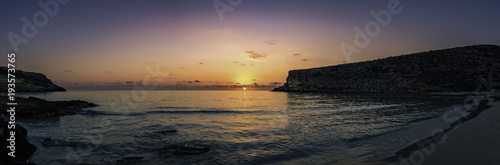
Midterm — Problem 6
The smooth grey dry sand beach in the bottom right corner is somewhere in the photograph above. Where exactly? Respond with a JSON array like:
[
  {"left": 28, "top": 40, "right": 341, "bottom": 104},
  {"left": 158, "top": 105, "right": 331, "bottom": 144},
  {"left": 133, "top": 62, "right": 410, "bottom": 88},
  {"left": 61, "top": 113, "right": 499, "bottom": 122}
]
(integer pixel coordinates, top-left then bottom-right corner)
[{"left": 396, "top": 98, "right": 500, "bottom": 165}]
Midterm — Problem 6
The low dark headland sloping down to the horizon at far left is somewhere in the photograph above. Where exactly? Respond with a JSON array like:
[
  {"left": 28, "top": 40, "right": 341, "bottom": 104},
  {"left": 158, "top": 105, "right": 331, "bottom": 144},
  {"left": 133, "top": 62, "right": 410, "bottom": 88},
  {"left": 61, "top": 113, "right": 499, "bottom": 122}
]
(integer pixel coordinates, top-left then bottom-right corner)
[{"left": 0, "top": 67, "right": 66, "bottom": 92}]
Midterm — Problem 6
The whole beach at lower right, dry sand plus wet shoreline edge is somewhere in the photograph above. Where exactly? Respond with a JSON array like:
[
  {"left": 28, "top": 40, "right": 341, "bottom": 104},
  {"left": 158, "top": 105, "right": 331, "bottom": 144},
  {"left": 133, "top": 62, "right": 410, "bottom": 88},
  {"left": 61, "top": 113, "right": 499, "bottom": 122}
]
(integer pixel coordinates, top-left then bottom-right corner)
[{"left": 380, "top": 94, "right": 500, "bottom": 165}]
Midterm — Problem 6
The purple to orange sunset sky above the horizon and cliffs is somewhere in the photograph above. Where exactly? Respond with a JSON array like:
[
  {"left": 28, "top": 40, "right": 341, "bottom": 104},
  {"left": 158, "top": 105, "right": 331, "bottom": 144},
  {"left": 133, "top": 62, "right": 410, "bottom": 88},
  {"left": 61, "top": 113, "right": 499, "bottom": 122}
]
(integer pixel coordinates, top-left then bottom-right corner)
[{"left": 0, "top": 0, "right": 500, "bottom": 89}]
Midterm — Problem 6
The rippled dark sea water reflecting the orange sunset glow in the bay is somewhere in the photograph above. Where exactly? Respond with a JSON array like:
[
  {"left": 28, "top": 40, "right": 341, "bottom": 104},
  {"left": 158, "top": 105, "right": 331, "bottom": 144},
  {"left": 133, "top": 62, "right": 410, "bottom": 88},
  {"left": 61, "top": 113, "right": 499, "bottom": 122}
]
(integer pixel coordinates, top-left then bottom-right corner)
[{"left": 19, "top": 91, "right": 463, "bottom": 164}]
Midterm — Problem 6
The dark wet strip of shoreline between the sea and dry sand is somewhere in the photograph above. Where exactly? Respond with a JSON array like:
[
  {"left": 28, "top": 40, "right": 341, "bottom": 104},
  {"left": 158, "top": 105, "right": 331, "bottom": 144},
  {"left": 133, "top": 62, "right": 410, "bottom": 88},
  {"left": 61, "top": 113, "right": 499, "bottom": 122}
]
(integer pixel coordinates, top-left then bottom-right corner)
[{"left": 378, "top": 93, "right": 500, "bottom": 165}]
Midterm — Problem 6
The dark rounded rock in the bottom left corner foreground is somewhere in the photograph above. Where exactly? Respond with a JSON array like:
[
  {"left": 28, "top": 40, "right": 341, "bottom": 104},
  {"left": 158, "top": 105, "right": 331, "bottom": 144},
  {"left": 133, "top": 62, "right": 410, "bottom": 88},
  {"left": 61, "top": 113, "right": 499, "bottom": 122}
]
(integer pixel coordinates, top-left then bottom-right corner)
[{"left": 0, "top": 118, "right": 36, "bottom": 165}]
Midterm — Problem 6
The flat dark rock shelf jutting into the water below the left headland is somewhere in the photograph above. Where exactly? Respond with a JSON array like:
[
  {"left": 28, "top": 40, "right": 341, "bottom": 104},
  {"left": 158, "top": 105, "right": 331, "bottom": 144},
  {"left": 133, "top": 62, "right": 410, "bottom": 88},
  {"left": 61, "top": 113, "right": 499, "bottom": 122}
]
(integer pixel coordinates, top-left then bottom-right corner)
[{"left": 0, "top": 96, "right": 97, "bottom": 119}]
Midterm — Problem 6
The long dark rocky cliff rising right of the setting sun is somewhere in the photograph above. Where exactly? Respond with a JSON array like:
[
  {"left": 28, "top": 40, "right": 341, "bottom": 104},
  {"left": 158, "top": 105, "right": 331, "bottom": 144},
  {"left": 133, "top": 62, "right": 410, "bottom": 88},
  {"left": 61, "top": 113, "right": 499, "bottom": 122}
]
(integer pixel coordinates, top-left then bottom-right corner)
[{"left": 274, "top": 45, "right": 500, "bottom": 92}]
